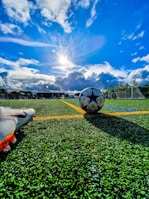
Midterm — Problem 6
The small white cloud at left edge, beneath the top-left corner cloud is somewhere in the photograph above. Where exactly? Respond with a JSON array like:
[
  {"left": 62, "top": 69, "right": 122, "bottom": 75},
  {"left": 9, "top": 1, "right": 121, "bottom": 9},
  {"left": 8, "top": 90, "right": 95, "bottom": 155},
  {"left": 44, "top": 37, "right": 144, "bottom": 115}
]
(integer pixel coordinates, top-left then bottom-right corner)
[{"left": 0, "top": 23, "right": 22, "bottom": 35}]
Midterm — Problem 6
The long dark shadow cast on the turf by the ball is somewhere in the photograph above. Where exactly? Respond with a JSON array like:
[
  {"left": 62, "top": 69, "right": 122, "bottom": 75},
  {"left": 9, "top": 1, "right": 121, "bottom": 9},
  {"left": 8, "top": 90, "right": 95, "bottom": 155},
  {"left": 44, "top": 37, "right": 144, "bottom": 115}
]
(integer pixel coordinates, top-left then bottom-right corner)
[{"left": 84, "top": 113, "right": 149, "bottom": 147}]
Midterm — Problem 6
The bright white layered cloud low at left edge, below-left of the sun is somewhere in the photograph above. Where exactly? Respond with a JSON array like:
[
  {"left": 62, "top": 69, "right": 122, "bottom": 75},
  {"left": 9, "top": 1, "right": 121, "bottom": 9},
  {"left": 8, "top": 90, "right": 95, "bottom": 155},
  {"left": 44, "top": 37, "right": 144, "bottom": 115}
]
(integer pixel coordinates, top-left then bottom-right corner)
[{"left": 0, "top": 57, "right": 55, "bottom": 90}]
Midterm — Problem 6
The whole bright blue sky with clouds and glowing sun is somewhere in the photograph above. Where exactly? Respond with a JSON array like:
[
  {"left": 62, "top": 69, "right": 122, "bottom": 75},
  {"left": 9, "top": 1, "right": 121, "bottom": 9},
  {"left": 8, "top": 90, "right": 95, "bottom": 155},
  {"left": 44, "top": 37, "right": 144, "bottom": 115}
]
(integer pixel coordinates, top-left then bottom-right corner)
[{"left": 0, "top": 0, "right": 149, "bottom": 91}]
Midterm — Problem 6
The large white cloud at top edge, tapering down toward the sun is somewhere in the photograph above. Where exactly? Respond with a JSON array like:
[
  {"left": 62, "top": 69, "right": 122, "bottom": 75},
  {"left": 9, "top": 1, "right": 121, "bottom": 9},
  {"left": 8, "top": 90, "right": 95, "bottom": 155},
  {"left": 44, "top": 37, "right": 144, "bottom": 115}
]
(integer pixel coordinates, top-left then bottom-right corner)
[{"left": 36, "top": 0, "right": 72, "bottom": 33}]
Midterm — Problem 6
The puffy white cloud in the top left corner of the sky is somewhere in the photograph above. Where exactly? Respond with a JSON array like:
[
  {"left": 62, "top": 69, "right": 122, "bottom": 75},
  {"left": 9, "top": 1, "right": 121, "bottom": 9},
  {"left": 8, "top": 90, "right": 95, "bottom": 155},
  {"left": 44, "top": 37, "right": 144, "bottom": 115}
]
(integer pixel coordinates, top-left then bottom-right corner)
[{"left": 2, "top": 0, "right": 33, "bottom": 24}]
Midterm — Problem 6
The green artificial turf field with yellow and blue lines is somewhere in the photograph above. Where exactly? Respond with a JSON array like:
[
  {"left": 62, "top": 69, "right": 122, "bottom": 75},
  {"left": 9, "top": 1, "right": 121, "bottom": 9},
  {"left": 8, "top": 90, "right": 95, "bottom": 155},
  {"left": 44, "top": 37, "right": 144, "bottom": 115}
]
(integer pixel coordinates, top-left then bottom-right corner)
[{"left": 0, "top": 99, "right": 149, "bottom": 199}]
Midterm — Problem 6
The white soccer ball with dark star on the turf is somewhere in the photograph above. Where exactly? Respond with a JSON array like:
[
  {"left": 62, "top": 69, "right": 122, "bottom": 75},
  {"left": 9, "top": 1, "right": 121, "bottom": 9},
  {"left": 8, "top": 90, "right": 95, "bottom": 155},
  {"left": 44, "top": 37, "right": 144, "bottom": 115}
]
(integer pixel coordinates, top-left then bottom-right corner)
[{"left": 79, "top": 87, "right": 105, "bottom": 113}]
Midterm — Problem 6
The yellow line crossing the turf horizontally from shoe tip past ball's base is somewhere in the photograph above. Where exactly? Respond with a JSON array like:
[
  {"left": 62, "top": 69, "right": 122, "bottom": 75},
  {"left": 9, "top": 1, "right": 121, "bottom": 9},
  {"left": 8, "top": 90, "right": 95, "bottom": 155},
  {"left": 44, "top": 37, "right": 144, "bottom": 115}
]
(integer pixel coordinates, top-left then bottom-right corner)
[{"left": 33, "top": 111, "right": 149, "bottom": 121}]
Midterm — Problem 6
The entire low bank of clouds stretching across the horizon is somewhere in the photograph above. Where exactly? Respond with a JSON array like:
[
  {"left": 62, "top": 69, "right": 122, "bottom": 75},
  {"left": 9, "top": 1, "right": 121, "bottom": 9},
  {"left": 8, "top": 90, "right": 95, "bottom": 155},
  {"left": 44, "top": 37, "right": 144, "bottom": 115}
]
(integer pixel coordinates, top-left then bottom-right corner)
[{"left": 0, "top": 58, "right": 149, "bottom": 92}]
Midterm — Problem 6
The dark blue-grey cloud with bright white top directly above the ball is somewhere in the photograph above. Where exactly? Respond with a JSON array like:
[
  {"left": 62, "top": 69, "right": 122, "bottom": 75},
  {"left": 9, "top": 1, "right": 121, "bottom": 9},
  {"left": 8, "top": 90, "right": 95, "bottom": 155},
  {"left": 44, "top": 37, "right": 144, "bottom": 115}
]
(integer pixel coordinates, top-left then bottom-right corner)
[{"left": 55, "top": 62, "right": 127, "bottom": 90}]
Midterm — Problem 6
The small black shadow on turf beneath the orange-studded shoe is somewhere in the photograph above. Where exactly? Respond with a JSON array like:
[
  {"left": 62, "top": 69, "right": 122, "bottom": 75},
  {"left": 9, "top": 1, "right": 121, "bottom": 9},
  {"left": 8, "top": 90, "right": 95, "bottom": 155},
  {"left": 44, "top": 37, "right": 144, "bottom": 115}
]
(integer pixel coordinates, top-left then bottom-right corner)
[{"left": 0, "top": 129, "right": 25, "bottom": 162}]
